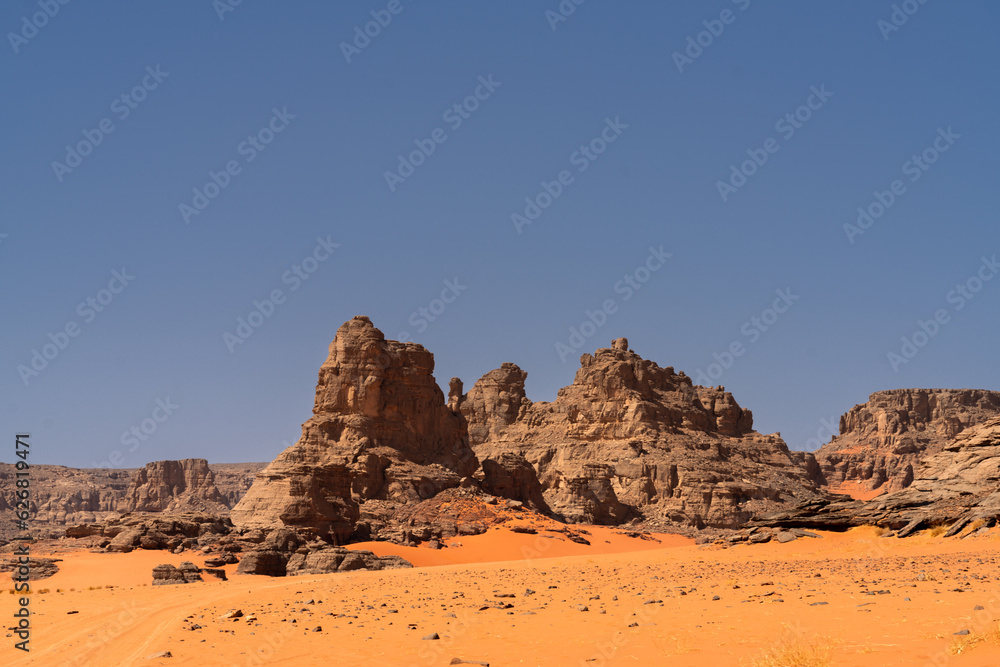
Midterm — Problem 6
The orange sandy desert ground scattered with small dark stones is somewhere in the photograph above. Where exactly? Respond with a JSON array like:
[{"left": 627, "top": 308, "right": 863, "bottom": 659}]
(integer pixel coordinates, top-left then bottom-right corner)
[{"left": 0, "top": 527, "right": 1000, "bottom": 667}]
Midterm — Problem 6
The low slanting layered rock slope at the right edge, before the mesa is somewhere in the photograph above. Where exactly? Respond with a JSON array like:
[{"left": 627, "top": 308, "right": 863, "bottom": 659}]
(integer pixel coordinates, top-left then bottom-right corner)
[{"left": 752, "top": 418, "right": 1000, "bottom": 537}]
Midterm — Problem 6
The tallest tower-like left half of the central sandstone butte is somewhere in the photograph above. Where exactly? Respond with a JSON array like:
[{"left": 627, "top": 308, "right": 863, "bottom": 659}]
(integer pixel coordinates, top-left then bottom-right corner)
[{"left": 231, "top": 317, "right": 479, "bottom": 544}]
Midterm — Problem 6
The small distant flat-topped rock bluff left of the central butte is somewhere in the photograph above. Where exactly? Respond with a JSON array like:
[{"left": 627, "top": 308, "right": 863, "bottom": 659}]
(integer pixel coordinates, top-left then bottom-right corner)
[{"left": 119, "top": 459, "right": 229, "bottom": 512}]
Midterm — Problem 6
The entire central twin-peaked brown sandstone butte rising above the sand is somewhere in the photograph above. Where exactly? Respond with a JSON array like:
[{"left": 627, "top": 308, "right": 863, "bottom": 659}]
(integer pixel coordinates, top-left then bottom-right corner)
[{"left": 230, "top": 317, "right": 825, "bottom": 544}]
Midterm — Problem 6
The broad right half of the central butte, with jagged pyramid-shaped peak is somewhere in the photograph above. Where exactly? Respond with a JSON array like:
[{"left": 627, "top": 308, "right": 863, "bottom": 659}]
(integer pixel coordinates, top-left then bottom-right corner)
[{"left": 460, "top": 338, "right": 822, "bottom": 528}]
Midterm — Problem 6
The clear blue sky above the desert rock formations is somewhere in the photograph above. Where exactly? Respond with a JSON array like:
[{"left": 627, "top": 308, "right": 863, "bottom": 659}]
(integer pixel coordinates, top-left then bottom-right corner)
[{"left": 0, "top": 0, "right": 1000, "bottom": 467}]
